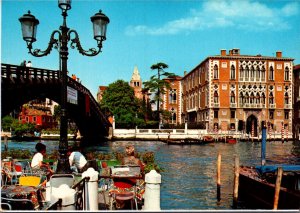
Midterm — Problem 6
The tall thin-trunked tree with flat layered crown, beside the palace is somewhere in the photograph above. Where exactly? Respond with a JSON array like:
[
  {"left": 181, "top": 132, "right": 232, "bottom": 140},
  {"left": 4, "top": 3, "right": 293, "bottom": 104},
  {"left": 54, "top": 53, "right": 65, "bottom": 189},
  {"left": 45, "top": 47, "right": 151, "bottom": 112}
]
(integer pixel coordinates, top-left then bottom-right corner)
[{"left": 144, "top": 62, "right": 175, "bottom": 128}]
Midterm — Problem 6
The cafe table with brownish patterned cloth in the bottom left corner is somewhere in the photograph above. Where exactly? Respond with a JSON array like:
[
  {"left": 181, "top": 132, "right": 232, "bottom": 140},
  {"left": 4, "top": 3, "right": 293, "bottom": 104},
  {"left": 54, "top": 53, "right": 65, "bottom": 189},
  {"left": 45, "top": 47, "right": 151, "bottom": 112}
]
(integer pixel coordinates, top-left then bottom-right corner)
[{"left": 1, "top": 185, "right": 41, "bottom": 209}]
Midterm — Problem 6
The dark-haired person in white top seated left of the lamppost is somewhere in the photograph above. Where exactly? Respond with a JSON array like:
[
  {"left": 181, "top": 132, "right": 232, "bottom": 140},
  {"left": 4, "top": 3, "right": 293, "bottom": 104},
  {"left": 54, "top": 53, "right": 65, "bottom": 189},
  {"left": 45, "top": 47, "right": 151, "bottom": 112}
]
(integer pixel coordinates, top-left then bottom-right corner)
[{"left": 31, "top": 142, "right": 54, "bottom": 180}]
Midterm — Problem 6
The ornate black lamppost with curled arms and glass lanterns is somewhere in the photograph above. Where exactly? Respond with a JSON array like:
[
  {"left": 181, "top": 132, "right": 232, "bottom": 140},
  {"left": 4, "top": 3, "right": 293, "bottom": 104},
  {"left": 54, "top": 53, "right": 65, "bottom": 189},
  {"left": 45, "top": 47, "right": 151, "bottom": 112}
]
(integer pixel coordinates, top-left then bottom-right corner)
[{"left": 19, "top": 0, "right": 109, "bottom": 174}]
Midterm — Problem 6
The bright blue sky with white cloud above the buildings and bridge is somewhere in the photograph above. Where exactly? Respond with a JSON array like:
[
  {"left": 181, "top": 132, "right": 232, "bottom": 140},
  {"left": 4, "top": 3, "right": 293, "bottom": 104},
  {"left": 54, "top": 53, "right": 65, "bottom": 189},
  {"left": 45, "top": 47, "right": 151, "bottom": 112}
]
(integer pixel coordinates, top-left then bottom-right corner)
[{"left": 1, "top": 0, "right": 300, "bottom": 97}]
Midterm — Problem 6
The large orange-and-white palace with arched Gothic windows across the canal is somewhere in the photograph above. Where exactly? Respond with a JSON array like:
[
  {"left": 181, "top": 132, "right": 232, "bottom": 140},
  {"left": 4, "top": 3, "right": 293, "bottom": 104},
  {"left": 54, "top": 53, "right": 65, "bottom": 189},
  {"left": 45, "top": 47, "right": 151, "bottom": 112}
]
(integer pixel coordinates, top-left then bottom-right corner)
[{"left": 181, "top": 49, "right": 294, "bottom": 136}]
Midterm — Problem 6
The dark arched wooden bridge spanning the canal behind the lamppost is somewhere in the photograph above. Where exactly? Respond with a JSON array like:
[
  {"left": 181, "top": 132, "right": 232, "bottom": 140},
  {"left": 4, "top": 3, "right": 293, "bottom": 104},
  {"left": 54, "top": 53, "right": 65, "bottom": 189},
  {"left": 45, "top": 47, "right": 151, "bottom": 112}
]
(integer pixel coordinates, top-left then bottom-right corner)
[{"left": 1, "top": 63, "right": 111, "bottom": 143}]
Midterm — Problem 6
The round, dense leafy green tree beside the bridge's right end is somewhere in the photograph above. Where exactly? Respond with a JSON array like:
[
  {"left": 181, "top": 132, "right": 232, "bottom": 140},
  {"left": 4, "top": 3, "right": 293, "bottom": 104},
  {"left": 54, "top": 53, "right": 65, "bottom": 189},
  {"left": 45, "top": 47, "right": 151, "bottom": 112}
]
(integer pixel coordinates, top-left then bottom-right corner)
[{"left": 100, "top": 80, "right": 139, "bottom": 127}]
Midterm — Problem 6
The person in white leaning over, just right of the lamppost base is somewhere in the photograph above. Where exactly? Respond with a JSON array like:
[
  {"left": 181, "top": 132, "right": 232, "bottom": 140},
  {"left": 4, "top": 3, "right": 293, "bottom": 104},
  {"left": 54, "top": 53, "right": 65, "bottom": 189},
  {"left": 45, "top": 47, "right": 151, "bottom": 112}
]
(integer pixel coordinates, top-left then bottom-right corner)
[{"left": 67, "top": 147, "right": 89, "bottom": 173}]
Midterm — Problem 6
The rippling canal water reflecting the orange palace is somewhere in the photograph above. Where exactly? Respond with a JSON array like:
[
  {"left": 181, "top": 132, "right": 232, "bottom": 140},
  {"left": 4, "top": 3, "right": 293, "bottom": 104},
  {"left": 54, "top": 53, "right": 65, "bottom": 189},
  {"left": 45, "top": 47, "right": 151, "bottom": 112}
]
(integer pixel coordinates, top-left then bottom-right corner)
[{"left": 1, "top": 141, "right": 300, "bottom": 210}]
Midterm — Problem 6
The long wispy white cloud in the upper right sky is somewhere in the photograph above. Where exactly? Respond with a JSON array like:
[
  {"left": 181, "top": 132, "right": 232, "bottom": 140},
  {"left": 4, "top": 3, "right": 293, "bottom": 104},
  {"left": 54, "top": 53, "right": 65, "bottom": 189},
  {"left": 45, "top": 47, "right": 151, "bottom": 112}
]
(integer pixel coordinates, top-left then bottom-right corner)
[{"left": 126, "top": 0, "right": 299, "bottom": 35}]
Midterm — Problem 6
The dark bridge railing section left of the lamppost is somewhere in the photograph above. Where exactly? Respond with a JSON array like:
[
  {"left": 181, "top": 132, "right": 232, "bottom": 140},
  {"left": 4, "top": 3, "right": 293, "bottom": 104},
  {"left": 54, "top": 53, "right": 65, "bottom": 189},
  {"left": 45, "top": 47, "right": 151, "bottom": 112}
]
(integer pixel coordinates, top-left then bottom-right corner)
[{"left": 1, "top": 63, "right": 60, "bottom": 79}]
